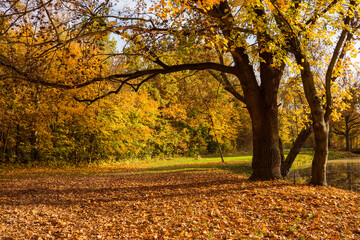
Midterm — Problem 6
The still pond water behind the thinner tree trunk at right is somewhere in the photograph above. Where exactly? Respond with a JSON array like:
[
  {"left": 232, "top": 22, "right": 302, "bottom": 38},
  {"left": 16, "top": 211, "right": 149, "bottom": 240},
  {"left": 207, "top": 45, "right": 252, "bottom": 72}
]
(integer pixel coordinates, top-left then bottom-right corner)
[{"left": 287, "top": 159, "right": 360, "bottom": 192}]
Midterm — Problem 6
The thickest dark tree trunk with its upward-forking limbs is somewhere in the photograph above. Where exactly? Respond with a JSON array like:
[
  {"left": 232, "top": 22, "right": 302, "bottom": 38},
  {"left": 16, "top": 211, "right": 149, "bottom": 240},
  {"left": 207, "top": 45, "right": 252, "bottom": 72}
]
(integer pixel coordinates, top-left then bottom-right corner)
[{"left": 208, "top": 1, "right": 285, "bottom": 180}]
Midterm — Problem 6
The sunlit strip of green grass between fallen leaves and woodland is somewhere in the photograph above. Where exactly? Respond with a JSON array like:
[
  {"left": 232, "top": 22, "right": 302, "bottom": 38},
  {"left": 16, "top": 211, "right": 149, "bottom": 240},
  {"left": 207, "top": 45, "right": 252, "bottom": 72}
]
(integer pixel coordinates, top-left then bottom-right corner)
[{"left": 0, "top": 149, "right": 360, "bottom": 175}]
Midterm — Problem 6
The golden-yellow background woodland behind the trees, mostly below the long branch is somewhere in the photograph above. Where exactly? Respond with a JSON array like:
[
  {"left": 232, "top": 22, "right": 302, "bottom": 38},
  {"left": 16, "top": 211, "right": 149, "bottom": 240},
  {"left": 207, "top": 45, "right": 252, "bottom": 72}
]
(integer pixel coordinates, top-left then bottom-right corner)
[{"left": 0, "top": 40, "right": 360, "bottom": 164}]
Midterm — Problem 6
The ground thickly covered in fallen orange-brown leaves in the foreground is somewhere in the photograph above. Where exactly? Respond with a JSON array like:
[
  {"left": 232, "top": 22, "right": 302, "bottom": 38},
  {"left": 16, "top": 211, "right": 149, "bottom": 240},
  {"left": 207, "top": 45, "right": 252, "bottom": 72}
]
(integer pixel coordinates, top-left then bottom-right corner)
[{"left": 0, "top": 171, "right": 360, "bottom": 240}]
